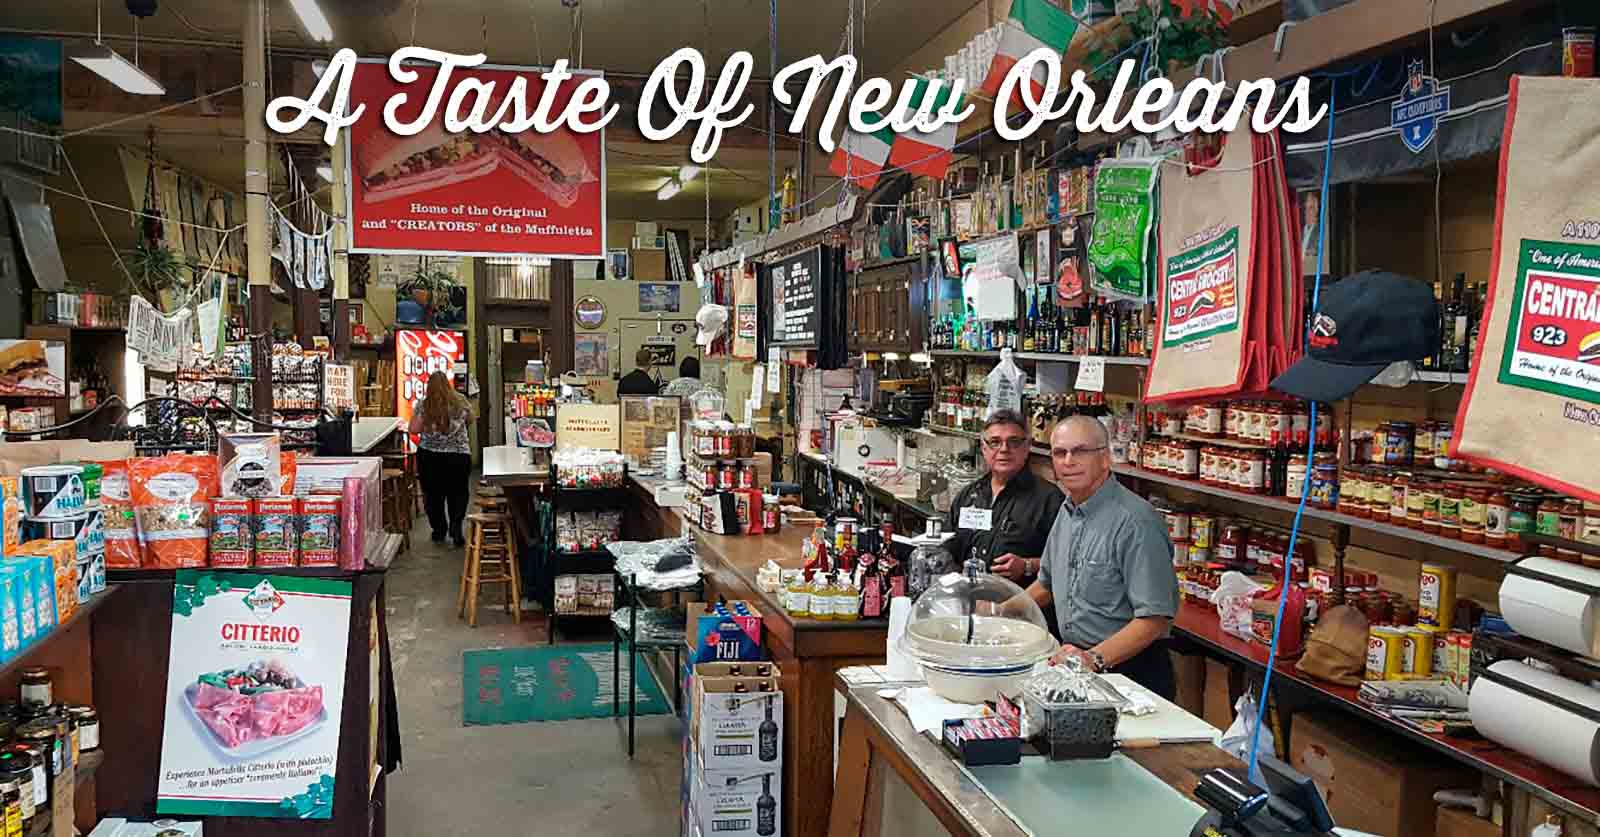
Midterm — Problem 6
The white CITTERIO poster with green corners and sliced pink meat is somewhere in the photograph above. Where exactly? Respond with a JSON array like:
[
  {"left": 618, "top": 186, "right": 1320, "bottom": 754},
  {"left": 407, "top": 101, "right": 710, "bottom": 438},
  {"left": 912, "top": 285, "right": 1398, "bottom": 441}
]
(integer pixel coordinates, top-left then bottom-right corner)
[{"left": 155, "top": 570, "right": 352, "bottom": 819}]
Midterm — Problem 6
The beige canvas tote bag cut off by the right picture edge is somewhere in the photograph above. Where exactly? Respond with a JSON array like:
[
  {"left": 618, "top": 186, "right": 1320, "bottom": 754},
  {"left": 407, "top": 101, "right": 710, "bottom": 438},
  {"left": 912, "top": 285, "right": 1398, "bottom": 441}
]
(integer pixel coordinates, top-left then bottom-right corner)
[{"left": 1451, "top": 75, "right": 1600, "bottom": 501}]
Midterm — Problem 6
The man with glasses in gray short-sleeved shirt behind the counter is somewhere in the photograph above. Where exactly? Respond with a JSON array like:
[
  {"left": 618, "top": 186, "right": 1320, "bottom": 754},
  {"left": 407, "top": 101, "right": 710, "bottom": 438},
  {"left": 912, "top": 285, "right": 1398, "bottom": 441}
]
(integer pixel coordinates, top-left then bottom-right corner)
[{"left": 1027, "top": 416, "right": 1178, "bottom": 699}]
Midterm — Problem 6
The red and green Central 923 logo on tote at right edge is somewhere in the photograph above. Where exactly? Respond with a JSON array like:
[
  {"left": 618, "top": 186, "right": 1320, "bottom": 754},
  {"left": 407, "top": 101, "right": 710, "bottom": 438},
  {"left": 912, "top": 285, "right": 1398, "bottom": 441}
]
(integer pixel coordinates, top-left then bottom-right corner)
[{"left": 1499, "top": 238, "right": 1600, "bottom": 403}]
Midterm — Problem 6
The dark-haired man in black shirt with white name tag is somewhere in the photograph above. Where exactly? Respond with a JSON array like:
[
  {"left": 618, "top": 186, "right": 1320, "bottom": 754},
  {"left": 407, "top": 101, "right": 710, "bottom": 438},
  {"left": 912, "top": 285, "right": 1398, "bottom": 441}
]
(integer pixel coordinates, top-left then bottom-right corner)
[{"left": 946, "top": 410, "right": 1061, "bottom": 586}]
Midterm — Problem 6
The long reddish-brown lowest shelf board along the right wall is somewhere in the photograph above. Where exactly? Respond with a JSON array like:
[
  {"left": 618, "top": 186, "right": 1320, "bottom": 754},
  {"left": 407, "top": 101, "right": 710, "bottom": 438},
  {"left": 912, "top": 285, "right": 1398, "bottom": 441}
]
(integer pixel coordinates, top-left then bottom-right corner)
[{"left": 1173, "top": 601, "right": 1600, "bottom": 823}]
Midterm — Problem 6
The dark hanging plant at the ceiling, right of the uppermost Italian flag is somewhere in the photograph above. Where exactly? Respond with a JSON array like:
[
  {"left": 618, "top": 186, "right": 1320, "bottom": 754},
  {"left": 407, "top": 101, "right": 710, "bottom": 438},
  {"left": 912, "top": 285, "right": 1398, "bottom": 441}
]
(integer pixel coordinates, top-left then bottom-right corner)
[{"left": 1085, "top": 0, "right": 1227, "bottom": 83}]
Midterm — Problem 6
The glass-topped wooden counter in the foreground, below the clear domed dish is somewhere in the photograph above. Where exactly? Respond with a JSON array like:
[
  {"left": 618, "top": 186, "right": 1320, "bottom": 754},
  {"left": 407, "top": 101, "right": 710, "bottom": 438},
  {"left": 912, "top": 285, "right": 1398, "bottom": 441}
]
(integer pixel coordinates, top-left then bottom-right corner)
[{"left": 827, "top": 677, "right": 1243, "bottom": 837}]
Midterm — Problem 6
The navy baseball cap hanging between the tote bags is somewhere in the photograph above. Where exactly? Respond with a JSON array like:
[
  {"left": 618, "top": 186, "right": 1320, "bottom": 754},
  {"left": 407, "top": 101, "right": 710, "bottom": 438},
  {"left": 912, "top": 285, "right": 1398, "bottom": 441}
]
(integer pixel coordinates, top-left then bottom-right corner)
[{"left": 1272, "top": 270, "right": 1438, "bottom": 402}]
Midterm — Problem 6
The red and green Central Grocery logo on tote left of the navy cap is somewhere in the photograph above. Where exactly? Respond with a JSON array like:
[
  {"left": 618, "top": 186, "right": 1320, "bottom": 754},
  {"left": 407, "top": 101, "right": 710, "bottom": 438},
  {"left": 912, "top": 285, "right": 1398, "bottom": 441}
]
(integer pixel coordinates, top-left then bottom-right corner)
[{"left": 1162, "top": 227, "right": 1238, "bottom": 347}]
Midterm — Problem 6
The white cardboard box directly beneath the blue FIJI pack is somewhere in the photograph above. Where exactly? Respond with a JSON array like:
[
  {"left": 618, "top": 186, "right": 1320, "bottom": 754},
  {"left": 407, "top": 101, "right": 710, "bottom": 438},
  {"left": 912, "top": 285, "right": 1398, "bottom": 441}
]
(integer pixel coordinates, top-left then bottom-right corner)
[{"left": 690, "top": 663, "right": 784, "bottom": 774}]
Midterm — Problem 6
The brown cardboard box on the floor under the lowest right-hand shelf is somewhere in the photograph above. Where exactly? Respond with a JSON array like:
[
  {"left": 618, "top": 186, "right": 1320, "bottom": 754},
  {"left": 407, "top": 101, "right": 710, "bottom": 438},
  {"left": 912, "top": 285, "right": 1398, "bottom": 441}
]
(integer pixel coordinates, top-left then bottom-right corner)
[{"left": 1290, "top": 712, "right": 1482, "bottom": 837}]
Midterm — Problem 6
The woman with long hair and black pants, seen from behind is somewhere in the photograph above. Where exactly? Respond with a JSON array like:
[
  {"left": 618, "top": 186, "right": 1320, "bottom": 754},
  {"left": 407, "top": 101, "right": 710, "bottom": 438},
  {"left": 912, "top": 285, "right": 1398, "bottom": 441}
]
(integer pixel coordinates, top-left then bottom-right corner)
[{"left": 410, "top": 371, "right": 472, "bottom": 546}]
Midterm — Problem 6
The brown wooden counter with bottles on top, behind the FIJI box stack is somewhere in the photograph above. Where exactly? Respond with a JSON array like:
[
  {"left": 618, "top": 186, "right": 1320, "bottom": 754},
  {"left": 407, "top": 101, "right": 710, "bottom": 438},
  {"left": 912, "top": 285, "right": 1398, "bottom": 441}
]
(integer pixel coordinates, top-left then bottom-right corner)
[{"left": 622, "top": 479, "right": 888, "bottom": 837}]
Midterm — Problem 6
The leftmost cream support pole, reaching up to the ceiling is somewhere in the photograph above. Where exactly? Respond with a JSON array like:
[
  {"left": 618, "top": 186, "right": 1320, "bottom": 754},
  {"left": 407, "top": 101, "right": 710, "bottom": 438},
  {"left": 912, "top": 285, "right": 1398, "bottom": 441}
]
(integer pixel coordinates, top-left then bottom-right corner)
[{"left": 243, "top": 0, "right": 272, "bottom": 419}]
